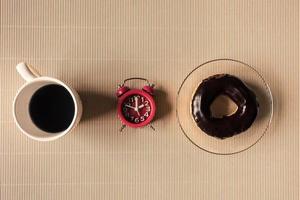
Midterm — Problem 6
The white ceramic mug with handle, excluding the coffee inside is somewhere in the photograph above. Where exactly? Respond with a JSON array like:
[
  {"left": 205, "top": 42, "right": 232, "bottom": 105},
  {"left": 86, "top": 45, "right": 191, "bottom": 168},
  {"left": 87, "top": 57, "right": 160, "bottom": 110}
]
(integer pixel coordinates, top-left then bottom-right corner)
[{"left": 13, "top": 63, "right": 82, "bottom": 141}]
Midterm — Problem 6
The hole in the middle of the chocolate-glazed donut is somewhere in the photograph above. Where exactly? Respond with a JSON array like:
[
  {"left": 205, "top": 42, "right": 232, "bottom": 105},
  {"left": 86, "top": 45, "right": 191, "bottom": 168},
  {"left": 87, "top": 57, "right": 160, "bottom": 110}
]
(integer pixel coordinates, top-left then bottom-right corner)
[{"left": 210, "top": 95, "right": 238, "bottom": 118}]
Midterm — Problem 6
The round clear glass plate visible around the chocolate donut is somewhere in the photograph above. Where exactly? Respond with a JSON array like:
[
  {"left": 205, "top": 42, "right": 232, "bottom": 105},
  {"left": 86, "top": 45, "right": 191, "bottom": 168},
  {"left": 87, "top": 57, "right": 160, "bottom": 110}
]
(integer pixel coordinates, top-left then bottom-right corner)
[{"left": 176, "top": 59, "right": 273, "bottom": 154}]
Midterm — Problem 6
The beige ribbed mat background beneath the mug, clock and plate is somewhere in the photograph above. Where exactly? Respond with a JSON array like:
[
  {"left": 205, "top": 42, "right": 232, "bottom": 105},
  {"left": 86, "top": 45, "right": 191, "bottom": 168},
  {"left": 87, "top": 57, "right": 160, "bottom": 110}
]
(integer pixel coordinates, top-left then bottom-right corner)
[{"left": 0, "top": 0, "right": 299, "bottom": 200}]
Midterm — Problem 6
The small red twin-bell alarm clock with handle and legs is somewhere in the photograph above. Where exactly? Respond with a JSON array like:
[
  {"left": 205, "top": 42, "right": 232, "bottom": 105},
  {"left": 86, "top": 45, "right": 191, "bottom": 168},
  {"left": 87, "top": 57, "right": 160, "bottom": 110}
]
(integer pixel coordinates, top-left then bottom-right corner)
[{"left": 116, "top": 78, "right": 156, "bottom": 131}]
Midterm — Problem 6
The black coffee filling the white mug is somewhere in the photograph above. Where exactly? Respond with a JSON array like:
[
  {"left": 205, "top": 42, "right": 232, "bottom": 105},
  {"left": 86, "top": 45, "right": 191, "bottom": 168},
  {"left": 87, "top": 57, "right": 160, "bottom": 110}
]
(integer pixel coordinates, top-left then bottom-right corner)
[{"left": 29, "top": 84, "right": 75, "bottom": 133}]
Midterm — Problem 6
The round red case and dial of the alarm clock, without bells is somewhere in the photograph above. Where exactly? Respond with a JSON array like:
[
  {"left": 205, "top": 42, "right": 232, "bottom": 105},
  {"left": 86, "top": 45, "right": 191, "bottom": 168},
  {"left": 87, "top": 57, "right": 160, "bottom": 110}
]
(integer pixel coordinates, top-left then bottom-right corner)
[{"left": 120, "top": 90, "right": 156, "bottom": 127}]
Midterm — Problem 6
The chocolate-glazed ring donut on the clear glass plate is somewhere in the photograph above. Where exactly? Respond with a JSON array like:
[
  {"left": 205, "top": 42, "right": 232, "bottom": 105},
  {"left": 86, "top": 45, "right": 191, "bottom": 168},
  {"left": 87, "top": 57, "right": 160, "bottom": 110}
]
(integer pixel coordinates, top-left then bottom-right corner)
[{"left": 192, "top": 74, "right": 259, "bottom": 139}]
